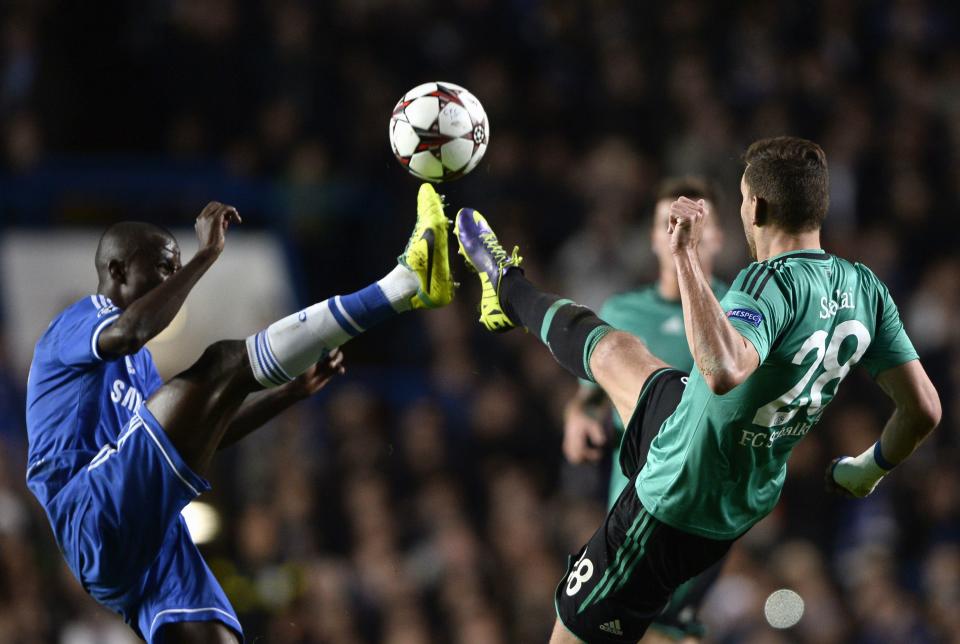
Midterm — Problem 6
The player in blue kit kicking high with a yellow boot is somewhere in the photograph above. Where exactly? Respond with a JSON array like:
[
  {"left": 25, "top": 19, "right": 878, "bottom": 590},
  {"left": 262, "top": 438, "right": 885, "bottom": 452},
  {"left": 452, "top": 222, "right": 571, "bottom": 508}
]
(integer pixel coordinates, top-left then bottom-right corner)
[{"left": 27, "top": 185, "right": 453, "bottom": 644}]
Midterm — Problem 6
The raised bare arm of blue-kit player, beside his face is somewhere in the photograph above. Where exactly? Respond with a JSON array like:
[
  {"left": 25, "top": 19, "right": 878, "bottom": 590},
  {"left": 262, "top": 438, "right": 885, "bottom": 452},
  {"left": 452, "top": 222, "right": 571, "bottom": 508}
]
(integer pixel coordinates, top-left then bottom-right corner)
[{"left": 97, "top": 202, "right": 240, "bottom": 360}]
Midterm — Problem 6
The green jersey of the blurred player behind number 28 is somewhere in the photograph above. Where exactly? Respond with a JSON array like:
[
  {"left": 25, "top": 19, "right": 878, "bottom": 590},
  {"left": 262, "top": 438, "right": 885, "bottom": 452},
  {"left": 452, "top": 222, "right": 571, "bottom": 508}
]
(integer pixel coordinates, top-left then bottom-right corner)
[{"left": 586, "top": 280, "right": 727, "bottom": 507}]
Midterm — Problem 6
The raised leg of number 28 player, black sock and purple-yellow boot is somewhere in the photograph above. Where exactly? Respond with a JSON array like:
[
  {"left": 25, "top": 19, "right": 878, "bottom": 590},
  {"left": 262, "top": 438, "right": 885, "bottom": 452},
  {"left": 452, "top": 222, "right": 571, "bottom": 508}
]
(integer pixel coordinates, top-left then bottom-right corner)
[{"left": 456, "top": 208, "right": 667, "bottom": 422}]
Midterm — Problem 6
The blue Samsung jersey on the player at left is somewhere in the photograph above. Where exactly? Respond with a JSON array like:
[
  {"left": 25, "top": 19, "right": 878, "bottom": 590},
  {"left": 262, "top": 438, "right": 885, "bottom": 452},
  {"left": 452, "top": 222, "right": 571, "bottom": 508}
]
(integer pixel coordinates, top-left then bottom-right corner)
[{"left": 27, "top": 295, "right": 163, "bottom": 507}]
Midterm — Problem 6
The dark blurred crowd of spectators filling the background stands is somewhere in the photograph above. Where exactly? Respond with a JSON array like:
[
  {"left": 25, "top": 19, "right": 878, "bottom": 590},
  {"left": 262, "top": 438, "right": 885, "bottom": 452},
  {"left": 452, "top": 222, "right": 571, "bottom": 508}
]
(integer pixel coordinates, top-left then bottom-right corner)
[{"left": 0, "top": 0, "right": 960, "bottom": 644}]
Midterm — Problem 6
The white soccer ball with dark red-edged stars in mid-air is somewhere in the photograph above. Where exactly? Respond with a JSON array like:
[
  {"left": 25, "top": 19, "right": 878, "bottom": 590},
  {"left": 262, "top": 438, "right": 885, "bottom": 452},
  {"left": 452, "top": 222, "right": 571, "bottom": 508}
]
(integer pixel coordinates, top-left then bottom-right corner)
[{"left": 390, "top": 83, "right": 490, "bottom": 182}]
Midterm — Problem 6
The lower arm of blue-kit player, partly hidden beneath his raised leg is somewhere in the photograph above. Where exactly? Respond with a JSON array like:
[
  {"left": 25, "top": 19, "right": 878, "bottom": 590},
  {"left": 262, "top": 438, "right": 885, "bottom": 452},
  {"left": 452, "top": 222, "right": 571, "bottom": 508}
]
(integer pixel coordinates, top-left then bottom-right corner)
[{"left": 217, "top": 349, "right": 346, "bottom": 449}]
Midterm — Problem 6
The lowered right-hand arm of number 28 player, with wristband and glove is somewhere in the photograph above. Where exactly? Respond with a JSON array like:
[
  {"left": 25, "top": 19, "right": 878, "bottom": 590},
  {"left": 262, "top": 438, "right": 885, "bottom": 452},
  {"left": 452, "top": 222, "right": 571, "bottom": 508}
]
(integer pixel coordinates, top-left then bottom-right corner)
[{"left": 827, "top": 360, "right": 941, "bottom": 497}]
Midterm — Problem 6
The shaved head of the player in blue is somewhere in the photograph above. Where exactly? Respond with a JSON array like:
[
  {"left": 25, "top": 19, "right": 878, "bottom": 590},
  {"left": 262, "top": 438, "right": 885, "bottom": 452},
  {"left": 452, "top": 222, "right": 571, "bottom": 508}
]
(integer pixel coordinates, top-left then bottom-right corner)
[{"left": 95, "top": 221, "right": 180, "bottom": 307}]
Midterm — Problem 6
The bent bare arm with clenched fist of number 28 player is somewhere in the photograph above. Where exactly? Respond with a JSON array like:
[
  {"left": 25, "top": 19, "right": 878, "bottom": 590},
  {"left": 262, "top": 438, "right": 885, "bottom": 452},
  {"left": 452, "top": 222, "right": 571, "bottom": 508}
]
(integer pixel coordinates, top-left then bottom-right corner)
[{"left": 669, "top": 197, "right": 760, "bottom": 394}]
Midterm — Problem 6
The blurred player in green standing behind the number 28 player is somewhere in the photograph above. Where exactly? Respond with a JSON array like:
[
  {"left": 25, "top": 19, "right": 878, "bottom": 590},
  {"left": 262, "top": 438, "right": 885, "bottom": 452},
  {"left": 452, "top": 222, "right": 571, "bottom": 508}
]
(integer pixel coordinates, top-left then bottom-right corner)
[{"left": 563, "top": 177, "right": 727, "bottom": 643}]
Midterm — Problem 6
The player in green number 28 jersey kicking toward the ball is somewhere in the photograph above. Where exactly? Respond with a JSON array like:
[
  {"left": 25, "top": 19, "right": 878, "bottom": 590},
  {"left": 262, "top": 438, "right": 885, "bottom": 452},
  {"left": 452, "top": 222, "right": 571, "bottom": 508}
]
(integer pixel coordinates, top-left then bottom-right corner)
[{"left": 456, "top": 137, "right": 941, "bottom": 644}]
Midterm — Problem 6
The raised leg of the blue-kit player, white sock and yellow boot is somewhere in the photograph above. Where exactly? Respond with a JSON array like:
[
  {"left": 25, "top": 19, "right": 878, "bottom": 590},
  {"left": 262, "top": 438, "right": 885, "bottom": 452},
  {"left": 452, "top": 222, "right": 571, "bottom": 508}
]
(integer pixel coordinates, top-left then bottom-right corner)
[{"left": 146, "top": 184, "right": 453, "bottom": 472}]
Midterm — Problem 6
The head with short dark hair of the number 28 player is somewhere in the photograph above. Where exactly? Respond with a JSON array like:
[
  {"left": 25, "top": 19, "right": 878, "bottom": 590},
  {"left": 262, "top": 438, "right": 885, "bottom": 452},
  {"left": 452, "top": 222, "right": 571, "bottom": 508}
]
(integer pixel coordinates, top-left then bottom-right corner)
[{"left": 743, "top": 136, "right": 830, "bottom": 233}]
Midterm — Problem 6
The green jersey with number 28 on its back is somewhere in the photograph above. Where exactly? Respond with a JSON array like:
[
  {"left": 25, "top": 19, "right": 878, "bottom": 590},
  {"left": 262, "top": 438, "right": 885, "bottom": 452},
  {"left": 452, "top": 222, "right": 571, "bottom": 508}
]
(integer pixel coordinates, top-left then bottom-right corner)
[{"left": 637, "top": 250, "right": 917, "bottom": 539}]
